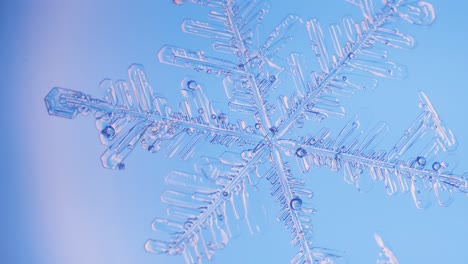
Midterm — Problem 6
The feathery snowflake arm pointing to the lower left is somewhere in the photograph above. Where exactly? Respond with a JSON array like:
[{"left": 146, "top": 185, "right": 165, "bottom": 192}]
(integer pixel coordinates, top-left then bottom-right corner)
[{"left": 146, "top": 144, "right": 267, "bottom": 263}]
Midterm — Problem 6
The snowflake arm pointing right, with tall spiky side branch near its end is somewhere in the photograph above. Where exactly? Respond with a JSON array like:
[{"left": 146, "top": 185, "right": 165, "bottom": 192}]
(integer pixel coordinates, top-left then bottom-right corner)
[{"left": 279, "top": 92, "right": 468, "bottom": 208}]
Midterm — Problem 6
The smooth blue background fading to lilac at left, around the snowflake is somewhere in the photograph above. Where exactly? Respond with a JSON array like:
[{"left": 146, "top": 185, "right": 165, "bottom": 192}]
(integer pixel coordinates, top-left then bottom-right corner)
[{"left": 0, "top": 0, "right": 468, "bottom": 264}]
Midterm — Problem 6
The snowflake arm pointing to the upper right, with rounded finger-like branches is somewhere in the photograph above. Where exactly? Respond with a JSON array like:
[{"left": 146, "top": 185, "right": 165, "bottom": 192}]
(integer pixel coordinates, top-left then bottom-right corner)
[{"left": 276, "top": 0, "right": 434, "bottom": 138}]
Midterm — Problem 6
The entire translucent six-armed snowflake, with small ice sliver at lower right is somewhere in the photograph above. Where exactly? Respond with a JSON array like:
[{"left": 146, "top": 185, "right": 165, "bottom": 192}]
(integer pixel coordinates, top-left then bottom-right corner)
[{"left": 45, "top": 0, "right": 468, "bottom": 263}]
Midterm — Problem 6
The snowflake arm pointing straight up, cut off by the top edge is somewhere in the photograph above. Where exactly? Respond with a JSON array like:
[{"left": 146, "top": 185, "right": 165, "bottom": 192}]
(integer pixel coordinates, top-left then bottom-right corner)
[{"left": 158, "top": 1, "right": 302, "bottom": 134}]
